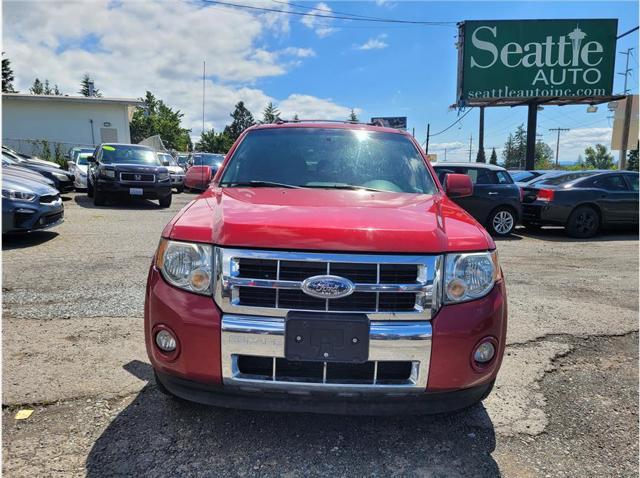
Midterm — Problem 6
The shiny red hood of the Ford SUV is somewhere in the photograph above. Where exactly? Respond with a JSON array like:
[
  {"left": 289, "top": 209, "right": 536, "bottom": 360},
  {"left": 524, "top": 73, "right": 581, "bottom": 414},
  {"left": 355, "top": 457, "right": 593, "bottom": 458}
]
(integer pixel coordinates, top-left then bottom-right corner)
[{"left": 163, "top": 188, "right": 495, "bottom": 253}]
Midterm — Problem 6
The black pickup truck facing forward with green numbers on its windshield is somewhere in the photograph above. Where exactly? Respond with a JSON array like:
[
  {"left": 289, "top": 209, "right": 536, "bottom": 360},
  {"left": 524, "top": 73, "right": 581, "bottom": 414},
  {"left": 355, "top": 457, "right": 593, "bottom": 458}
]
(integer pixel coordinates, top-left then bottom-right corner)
[{"left": 87, "top": 143, "right": 171, "bottom": 207}]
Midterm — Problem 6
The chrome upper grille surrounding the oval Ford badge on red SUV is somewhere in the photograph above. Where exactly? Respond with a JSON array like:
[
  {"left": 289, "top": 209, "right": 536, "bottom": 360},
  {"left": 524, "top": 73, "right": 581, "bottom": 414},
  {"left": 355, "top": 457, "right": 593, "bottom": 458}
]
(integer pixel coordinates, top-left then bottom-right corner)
[{"left": 216, "top": 248, "right": 441, "bottom": 320}]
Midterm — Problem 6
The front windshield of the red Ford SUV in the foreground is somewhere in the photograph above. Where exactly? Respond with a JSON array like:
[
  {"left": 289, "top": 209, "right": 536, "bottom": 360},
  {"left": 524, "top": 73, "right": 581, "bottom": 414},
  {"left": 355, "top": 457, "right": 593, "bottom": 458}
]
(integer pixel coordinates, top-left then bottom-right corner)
[{"left": 221, "top": 128, "right": 436, "bottom": 194}]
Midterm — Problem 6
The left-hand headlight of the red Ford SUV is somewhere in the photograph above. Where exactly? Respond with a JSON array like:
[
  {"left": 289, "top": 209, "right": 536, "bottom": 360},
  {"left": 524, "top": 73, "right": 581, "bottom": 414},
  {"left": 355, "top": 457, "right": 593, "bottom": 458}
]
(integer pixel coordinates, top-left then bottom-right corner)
[{"left": 156, "top": 239, "right": 213, "bottom": 295}]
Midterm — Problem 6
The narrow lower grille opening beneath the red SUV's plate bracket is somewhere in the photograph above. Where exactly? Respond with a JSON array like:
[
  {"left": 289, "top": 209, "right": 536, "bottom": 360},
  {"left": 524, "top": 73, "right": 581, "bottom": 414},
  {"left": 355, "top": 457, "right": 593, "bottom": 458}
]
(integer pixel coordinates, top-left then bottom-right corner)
[{"left": 237, "top": 355, "right": 413, "bottom": 384}]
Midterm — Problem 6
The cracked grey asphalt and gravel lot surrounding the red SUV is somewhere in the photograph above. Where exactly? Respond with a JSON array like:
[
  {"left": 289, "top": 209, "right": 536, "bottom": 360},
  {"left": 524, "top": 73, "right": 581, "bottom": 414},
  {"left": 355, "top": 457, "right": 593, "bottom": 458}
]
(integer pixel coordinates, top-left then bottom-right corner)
[{"left": 2, "top": 194, "right": 638, "bottom": 477}]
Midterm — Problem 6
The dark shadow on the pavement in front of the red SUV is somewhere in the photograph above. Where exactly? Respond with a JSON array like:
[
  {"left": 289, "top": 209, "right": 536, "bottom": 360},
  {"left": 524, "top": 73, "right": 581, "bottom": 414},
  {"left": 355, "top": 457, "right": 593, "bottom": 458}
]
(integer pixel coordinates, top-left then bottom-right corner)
[{"left": 86, "top": 362, "right": 500, "bottom": 477}]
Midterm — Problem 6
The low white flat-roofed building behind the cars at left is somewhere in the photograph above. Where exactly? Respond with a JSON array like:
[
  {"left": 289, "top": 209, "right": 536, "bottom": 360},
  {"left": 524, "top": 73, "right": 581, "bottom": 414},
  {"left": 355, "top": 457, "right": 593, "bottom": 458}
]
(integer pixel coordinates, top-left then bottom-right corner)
[{"left": 2, "top": 93, "right": 143, "bottom": 154}]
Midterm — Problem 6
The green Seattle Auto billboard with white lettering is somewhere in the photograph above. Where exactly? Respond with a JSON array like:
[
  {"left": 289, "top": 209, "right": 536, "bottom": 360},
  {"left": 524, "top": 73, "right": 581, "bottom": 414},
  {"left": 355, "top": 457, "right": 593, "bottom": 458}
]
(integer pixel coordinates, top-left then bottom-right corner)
[{"left": 458, "top": 19, "right": 618, "bottom": 106}]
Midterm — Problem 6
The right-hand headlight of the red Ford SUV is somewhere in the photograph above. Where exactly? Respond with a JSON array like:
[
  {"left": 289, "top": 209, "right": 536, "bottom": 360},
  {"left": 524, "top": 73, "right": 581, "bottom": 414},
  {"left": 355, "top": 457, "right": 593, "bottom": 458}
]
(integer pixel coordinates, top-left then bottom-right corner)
[{"left": 444, "top": 251, "right": 501, "bottom": 304}]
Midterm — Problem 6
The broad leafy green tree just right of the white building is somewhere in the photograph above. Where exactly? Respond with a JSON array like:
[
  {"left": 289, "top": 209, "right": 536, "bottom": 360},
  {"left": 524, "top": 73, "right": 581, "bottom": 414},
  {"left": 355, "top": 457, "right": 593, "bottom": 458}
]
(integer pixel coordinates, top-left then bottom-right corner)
[{"left": 129, "top": 91, "right": 191, "bottom": 151}]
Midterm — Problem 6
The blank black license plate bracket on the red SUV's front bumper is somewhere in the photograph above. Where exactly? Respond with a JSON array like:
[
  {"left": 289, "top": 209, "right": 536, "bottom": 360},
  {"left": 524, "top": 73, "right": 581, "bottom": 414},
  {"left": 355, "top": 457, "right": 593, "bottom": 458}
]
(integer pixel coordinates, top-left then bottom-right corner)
[{"left": 284, "top": 312, "right": 370, "bottom": 363}]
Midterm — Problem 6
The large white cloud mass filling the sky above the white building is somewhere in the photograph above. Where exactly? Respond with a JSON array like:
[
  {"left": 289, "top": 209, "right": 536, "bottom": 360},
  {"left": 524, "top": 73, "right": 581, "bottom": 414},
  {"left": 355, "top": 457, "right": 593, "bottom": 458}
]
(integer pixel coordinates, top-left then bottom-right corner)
[{"left": 2, "top": 0, "right": 346, "bottom": 138}]
